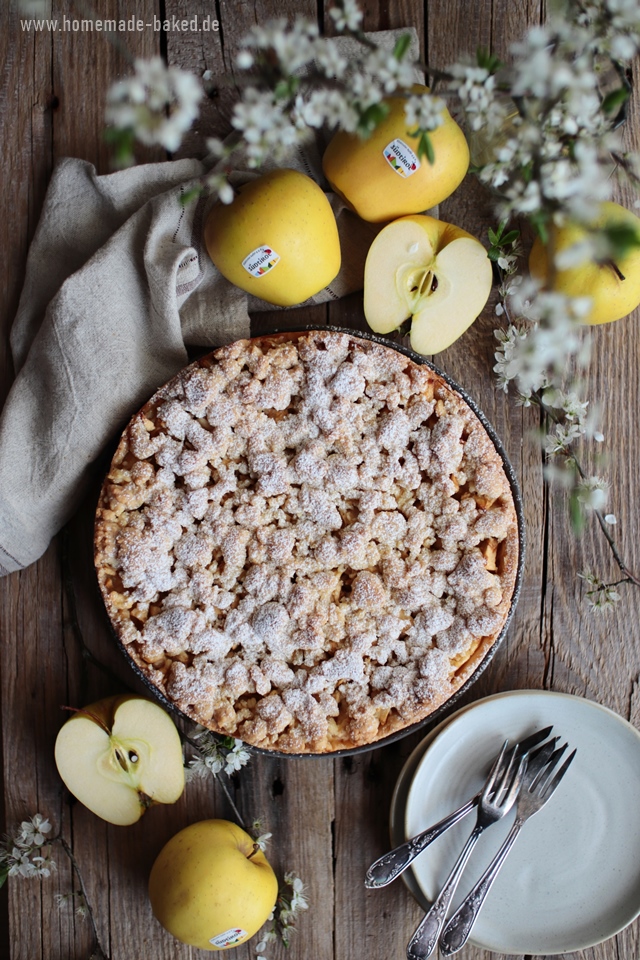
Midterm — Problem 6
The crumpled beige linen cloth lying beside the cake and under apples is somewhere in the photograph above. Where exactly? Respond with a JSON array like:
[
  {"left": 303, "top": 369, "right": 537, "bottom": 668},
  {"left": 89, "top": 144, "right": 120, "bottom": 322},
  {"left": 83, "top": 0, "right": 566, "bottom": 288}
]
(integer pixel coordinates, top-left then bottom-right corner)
[{"left": 0, "top": 31, "right": 418, "bottom": 575}]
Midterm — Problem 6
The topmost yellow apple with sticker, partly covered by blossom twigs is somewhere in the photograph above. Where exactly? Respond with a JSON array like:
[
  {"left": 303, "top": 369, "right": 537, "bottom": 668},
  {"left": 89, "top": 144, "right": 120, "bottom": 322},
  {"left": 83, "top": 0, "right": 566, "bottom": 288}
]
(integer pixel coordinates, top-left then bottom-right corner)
[{"left": 322, "top": 85, "right": 469, "bottom": 223}]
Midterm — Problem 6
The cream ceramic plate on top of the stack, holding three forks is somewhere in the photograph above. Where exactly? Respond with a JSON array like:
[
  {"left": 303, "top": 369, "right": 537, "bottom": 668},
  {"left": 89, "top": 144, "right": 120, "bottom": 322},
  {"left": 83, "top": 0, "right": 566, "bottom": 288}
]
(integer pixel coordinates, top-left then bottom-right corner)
[{"left": 404, "top": 691, "right": 640, "bottom": 955}]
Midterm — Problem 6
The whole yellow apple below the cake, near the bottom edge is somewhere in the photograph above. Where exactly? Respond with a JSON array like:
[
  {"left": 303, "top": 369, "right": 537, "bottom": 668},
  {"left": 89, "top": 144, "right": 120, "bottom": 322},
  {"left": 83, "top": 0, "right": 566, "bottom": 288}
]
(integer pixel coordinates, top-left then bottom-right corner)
[{"left": 149, "top": 820, "right": 278, "bottom": 950}]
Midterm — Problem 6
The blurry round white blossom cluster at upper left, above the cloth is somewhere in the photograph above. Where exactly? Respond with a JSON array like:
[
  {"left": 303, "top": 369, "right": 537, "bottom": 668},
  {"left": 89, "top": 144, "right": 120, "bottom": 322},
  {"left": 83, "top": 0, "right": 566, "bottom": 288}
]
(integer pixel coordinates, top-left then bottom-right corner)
[{"left": 105, "top": 57, "right": 202, "bottom": 151}]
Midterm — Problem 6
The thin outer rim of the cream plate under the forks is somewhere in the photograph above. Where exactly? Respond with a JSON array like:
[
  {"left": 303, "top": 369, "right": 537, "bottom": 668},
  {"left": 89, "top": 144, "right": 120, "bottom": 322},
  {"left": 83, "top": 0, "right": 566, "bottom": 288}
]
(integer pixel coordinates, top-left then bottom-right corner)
[{"left": 400, "top": 689, "right": 640, "bottom": 956}]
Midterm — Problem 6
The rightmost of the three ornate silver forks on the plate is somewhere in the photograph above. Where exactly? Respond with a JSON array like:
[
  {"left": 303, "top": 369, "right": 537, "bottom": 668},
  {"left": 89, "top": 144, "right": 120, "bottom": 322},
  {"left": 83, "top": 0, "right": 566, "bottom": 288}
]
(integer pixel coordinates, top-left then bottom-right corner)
[{"left": 440, "top": 743, "right": 576, "bottom": 957}]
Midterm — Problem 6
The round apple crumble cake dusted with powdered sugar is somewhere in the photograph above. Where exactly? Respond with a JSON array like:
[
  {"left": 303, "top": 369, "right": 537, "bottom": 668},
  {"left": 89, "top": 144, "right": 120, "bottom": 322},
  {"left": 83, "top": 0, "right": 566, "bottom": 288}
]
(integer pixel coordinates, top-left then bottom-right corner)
[{"left": 95, "top": 331, "right": 519, "bottom": 753}]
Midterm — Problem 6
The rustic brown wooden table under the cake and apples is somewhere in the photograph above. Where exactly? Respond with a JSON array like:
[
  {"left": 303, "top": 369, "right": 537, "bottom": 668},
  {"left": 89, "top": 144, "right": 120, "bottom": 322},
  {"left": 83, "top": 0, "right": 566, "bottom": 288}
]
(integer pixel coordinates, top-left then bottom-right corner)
[{"left": 0, "top": 0, "right": 640, "bottom": 960}]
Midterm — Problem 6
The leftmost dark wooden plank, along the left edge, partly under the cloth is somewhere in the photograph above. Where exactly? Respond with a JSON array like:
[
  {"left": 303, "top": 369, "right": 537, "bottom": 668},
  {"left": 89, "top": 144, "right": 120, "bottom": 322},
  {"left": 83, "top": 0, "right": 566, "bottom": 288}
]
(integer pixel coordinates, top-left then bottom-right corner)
[{"left": 0, "top": 4, "right": 55, "bottom": 957}]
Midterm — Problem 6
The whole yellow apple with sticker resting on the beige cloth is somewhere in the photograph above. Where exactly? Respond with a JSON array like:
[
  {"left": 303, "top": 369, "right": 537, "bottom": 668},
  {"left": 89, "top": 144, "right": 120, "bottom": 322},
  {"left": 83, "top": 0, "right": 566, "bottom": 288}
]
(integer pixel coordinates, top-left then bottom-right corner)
[{"left": 204, "top": 170, "right": 340, "bottom": 307}]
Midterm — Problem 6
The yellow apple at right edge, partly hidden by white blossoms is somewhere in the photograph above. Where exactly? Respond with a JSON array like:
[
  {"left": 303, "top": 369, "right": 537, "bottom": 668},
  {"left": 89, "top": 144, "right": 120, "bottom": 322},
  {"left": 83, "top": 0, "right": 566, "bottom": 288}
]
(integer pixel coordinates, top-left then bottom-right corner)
[{"left": 529, "top": 202, "right": 640, "bottom": 324}]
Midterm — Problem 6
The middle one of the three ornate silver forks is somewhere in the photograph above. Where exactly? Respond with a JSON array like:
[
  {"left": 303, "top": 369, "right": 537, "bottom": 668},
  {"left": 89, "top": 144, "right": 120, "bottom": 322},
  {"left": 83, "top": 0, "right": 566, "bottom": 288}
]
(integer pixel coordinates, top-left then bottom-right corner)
[{"left": 407, "top": 741, "right": 527, "bottom": 960}]
